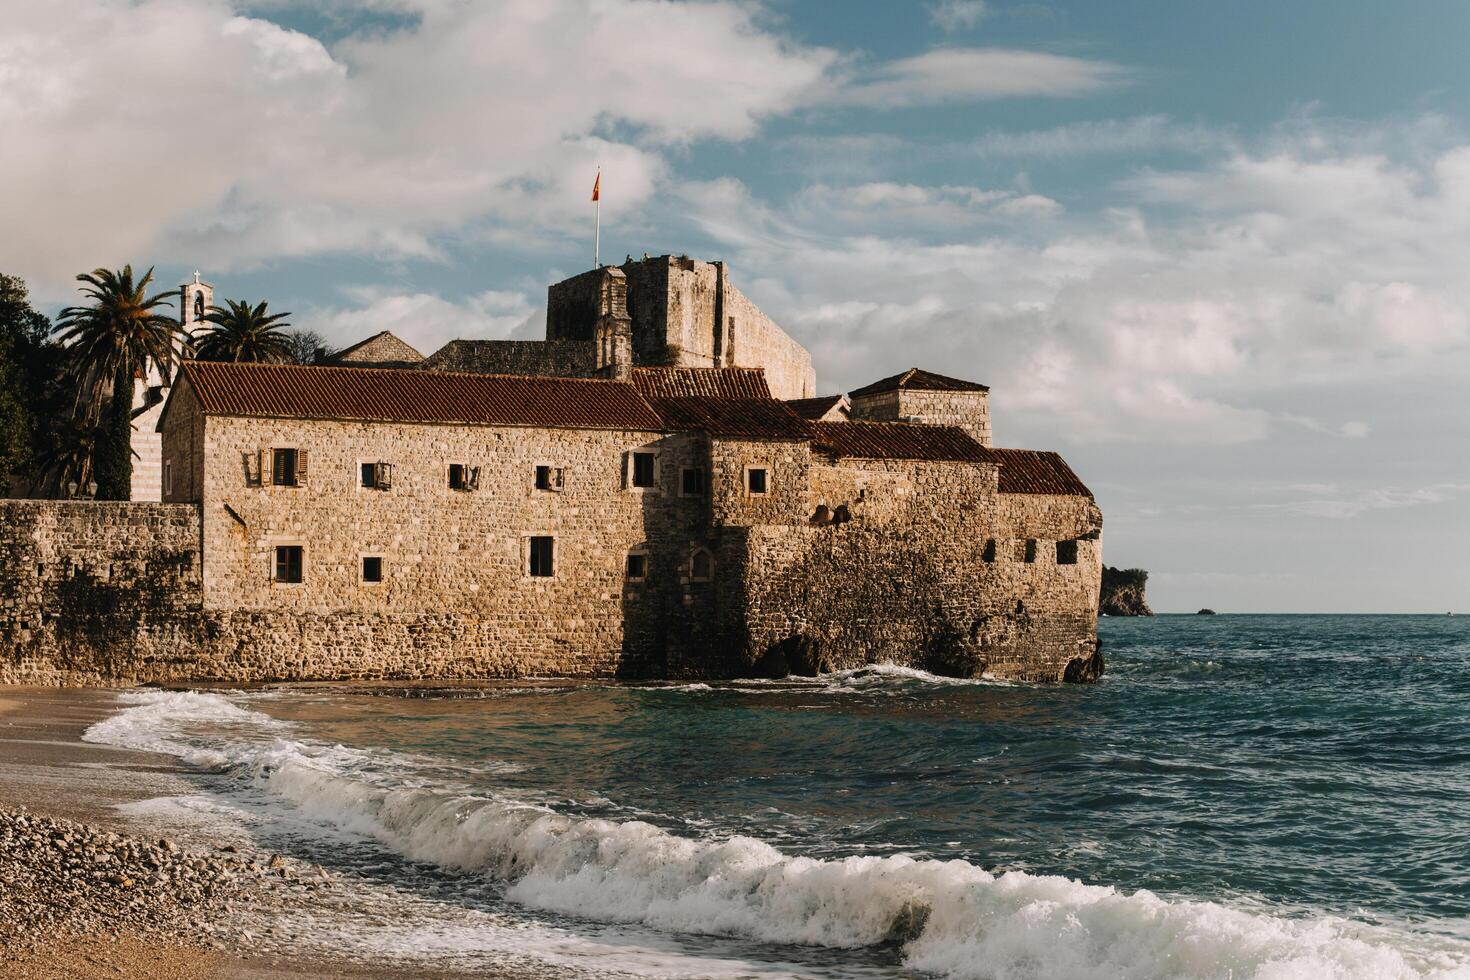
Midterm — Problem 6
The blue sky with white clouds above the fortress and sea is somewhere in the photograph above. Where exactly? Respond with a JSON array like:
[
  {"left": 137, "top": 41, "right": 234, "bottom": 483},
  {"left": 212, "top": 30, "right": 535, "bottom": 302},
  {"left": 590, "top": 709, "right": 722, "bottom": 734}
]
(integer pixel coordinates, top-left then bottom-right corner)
[{"left": 0, "top": 0, "right": 1470, "bottom": 613}]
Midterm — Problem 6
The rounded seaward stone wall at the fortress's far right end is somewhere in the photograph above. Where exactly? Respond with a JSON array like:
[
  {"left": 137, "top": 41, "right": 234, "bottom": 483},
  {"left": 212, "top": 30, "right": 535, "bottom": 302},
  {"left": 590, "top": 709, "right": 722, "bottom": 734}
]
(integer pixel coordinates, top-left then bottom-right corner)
[{"left": 735, "top": 460, "right": 1101, "bottom": 680}]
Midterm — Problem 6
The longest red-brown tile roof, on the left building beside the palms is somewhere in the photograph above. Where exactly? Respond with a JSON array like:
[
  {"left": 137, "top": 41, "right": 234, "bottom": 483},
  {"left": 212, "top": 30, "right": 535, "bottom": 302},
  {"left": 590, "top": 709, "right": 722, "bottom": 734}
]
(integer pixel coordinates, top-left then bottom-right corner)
[{"left": 182, "top": 361, "right": 663, "bottom": 432}]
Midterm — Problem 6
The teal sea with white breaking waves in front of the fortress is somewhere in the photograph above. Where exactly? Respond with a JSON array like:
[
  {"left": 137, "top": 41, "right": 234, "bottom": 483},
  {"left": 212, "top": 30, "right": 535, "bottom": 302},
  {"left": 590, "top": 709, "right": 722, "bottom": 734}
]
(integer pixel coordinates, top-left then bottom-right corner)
[{"left": 85, "top": 614, "right": 1470, "bottom": 980}]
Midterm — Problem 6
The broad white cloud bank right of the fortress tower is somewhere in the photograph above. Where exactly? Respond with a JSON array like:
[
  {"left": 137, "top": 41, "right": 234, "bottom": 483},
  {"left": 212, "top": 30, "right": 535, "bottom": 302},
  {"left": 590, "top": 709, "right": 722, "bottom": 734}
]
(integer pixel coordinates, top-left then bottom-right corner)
[{"left": 673, "top": 119, "right": 1470, "bottom": 449}]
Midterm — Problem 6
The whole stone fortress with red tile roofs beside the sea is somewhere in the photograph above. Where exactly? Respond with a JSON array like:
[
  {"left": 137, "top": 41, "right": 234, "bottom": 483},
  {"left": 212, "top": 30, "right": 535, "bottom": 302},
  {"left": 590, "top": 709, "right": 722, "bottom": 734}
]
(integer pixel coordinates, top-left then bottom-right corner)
[{"left": 0, "top": 256, "right": 1103, "bottom": 682}]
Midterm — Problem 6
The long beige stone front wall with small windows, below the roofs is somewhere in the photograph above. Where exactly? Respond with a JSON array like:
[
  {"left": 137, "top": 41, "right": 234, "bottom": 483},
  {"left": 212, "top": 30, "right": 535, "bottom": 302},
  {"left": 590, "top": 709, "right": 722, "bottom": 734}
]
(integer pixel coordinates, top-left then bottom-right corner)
[{"left": 0, "top": 417, "right": 1101, "bottom": 683}]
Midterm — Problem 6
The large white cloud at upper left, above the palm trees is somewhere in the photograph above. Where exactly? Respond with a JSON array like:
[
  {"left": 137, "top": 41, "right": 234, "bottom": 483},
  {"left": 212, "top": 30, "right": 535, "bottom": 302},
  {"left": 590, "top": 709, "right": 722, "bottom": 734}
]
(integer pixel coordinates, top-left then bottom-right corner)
[{"left": 0, "top": 0, "right": 836, "bottom": 295}]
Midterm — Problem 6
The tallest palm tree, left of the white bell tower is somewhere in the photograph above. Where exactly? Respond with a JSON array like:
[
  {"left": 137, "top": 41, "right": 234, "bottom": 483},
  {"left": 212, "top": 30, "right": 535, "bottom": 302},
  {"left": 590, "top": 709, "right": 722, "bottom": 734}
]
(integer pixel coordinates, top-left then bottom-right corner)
[{"left": 56, "top": 264, "right": 188, "bottom": 500}]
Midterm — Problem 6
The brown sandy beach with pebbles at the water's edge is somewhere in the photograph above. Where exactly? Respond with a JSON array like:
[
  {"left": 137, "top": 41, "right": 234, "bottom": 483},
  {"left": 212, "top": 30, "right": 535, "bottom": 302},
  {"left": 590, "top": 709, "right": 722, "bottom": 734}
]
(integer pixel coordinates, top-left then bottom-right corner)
[{"left": 0, "top": 688, "right": 470, "bottom": 980}]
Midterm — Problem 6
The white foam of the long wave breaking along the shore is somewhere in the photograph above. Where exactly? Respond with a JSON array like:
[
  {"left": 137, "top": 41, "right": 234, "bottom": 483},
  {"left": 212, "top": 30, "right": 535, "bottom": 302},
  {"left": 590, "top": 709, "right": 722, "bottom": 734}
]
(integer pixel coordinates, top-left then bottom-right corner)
[{"left": 88, "top": 693, "right": 1470, "bottom": 980}]
